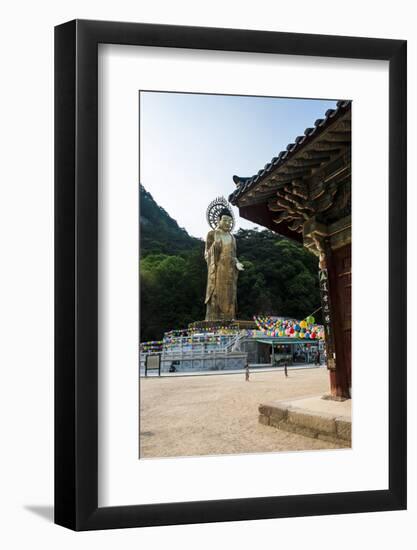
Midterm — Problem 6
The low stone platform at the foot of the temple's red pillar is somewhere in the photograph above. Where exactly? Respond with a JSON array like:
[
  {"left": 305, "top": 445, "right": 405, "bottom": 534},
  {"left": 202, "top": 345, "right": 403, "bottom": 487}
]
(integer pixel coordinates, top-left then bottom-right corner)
[{"left": 259, "top": 396, "right": 352, "bottom": 447}]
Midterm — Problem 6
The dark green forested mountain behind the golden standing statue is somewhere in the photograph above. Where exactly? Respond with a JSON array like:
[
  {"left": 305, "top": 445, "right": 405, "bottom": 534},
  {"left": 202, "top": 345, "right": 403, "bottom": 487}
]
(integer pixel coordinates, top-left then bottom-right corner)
[{"left": 140, "top": 186, "right": 320, "bottom": 341}]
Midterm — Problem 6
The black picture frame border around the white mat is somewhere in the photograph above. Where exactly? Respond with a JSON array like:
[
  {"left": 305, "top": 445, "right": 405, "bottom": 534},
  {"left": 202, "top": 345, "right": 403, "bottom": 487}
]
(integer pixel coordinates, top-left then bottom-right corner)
[{"left": 55, "top": 20, "right": 407, "bottom": 530}]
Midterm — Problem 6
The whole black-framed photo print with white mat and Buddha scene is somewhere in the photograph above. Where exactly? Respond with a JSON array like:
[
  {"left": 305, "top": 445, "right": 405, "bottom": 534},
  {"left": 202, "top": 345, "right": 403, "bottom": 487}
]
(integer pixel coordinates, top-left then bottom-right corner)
[{"left": 55, "top": 20, "right": 406, "bottom": 530}]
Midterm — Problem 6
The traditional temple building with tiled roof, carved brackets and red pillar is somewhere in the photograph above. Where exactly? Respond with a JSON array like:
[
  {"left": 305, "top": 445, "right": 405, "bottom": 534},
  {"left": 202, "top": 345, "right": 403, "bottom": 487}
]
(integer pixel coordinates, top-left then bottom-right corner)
[{"left": 229, "top": 101, "right": 352, "bottom": 399}]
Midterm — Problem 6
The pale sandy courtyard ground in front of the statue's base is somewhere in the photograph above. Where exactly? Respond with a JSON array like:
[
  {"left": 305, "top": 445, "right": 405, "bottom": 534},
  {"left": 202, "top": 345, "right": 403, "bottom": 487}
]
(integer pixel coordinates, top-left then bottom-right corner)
[{"left": 140, "top": 368, "right": 337, "bottom": 458}]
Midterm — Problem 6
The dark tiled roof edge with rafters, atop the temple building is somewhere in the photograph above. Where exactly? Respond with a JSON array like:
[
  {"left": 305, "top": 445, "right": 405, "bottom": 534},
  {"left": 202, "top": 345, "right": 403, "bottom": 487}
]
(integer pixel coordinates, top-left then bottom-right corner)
[{"left": 229, "top": 100, "right": 351, "bottom": 206}]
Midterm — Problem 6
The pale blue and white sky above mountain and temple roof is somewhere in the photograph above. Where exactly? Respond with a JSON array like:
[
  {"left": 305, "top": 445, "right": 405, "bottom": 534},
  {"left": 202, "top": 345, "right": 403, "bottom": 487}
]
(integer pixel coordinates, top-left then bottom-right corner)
[{"left": 140, "top": 92, "right": 336, "bottom": 238}]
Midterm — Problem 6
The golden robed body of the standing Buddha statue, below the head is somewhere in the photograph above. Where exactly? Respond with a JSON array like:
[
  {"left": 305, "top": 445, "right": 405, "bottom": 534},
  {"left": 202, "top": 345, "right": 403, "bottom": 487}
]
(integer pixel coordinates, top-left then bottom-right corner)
[{"left": 204, "top": 229, "right": 238, "bottom": 321}]
